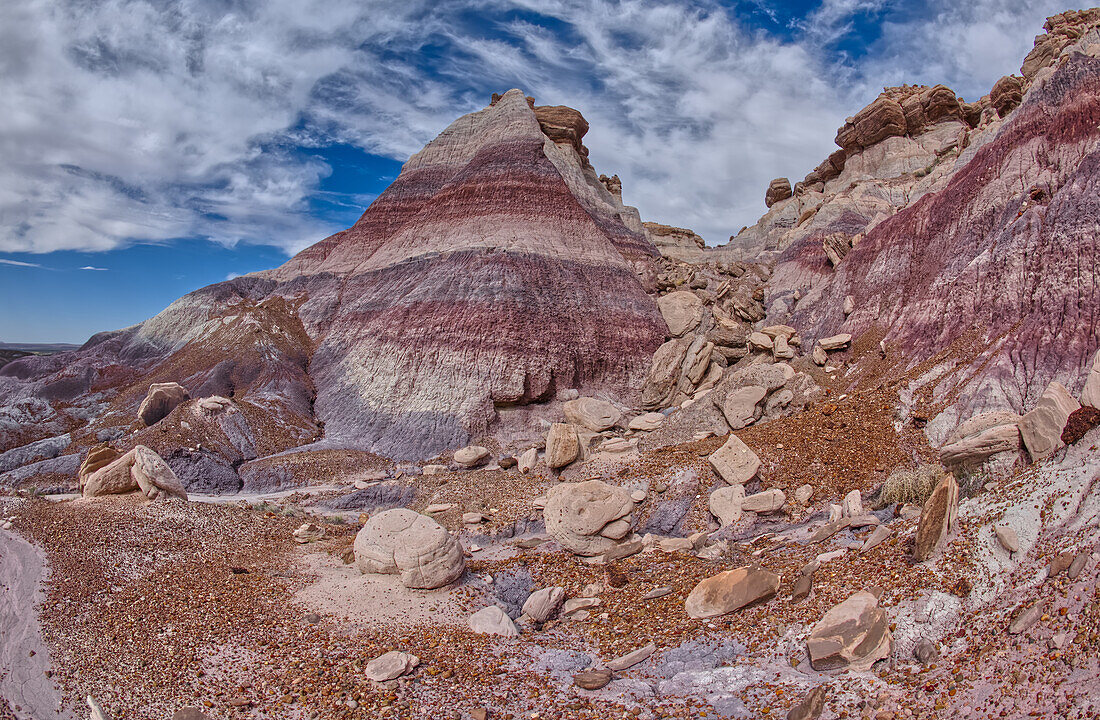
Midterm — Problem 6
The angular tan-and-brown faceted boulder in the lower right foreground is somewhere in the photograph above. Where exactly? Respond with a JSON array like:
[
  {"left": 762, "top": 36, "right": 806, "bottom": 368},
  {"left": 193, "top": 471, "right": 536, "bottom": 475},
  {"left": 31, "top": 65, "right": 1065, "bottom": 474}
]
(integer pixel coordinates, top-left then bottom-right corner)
[{"left": 806, "top": 590, "right": 893, "bottom": 671}]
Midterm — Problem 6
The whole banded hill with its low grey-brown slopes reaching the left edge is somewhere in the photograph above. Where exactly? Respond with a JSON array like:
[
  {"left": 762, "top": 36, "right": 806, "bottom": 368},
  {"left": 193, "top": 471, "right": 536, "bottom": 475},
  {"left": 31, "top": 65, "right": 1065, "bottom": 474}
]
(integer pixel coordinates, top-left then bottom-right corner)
[{"left": 0, "top": 90, "right": 666, "bottom": 472}]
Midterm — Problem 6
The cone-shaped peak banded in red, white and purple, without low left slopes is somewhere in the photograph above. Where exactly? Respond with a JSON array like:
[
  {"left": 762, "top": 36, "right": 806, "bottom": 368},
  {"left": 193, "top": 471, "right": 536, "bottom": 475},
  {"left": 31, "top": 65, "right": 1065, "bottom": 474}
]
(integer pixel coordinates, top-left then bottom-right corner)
[{"left": 262, "top": 90, "right": 664, "bottom": 458}]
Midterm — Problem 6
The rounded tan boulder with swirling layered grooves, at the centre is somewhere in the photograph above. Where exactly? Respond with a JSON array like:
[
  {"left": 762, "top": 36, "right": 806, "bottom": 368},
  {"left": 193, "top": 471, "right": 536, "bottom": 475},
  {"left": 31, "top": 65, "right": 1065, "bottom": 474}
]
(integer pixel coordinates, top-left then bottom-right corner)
[{"left": 542, "top": 480, "right": 635, "bottom": 556}]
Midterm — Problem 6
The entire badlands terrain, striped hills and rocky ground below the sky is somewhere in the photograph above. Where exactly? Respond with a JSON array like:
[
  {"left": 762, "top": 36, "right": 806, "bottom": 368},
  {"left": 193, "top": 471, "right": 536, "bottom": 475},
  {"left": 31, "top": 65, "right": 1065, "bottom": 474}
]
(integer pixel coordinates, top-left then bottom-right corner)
[{"left": 0, "top": 9, "right": 1100, "bottom": 720}]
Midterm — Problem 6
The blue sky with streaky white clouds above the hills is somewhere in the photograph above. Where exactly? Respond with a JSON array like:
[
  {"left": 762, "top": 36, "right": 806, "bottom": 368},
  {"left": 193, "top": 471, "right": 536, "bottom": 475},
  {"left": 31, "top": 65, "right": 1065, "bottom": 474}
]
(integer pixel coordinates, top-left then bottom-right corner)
[{"left": 0, "top": 0, "right": 1064, "bottom": 342}]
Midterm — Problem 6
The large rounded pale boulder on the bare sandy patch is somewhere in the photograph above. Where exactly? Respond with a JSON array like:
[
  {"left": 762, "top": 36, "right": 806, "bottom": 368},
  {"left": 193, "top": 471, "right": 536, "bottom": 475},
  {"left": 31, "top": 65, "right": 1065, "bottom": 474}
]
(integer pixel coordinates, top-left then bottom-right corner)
[{"left": 354, "top": 508, "right": 466, "bottom": 589}]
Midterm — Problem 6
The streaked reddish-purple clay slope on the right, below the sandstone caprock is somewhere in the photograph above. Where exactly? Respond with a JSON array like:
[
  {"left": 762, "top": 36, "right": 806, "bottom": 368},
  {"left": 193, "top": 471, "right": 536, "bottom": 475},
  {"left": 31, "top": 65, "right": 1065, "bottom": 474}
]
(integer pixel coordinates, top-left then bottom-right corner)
[{"left": 776, "top": 23, "right": 1100, "bottom": 430}]
